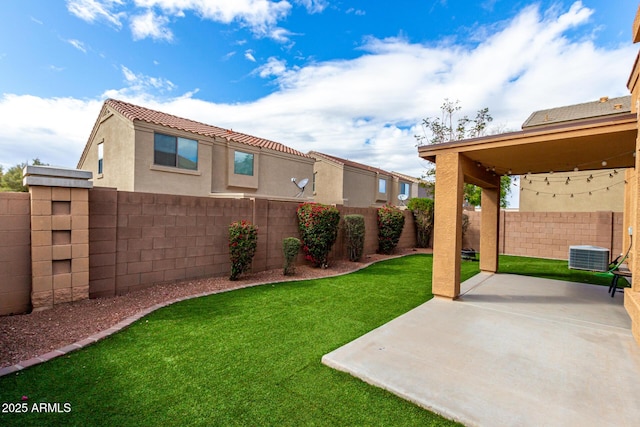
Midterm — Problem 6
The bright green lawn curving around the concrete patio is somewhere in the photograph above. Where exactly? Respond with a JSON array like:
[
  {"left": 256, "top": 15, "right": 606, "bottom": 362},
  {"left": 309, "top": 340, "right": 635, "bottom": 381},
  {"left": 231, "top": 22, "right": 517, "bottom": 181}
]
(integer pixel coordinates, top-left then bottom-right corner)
[{"left": 0, "top": 255, "right": 612, "bottom": 427}]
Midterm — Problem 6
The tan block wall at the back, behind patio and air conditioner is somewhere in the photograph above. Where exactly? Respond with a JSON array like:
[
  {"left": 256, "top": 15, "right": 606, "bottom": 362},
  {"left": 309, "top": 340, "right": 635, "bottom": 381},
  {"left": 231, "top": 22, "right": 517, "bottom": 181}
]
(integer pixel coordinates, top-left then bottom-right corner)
[{"left": 463, "top": 211, "right": 627, "bottom": 260}]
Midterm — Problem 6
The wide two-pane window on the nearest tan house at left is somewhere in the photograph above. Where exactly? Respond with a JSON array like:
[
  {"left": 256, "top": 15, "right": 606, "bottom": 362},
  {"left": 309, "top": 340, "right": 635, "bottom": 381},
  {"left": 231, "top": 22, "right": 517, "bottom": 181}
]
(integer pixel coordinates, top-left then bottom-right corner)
[{"left": 153, "top": 133, "right": 198, "bottom": 170}]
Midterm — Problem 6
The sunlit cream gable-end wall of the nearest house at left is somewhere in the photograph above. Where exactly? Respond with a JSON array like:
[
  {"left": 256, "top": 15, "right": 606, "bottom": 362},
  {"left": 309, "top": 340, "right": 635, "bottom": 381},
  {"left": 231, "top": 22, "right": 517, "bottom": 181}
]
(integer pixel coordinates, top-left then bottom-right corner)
[{"left": 78, "top": 110, "right": 135, "bottom": 191}]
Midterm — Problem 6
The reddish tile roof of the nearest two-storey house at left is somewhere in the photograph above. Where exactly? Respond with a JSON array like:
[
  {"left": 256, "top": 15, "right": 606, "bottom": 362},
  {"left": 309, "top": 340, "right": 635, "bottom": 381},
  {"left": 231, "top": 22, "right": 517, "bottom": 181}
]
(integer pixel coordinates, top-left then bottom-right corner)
[{"left": 104, "top": 99, "right": 310, "bottom": 158}]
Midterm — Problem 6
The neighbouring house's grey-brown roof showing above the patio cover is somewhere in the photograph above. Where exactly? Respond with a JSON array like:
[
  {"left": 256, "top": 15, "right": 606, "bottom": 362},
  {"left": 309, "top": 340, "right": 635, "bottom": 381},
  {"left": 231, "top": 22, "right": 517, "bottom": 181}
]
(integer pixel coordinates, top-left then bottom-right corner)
[{"left": 522, "top": 96, "right": 631, "bottom": 129}]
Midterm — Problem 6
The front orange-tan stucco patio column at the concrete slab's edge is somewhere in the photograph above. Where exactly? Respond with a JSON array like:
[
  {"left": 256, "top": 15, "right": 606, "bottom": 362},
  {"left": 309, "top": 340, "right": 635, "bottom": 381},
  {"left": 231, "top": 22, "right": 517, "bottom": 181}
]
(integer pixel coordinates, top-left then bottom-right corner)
[{"left": 432, "top": 153, "right": 464, "bottom": 299}]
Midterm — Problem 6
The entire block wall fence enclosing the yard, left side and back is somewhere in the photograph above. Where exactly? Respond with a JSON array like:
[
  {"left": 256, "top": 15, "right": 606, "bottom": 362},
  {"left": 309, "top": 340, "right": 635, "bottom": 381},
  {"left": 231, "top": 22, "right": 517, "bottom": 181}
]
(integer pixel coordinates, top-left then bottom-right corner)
[{"left": 0, "top": 188, "right": 626, "bottom": 315}]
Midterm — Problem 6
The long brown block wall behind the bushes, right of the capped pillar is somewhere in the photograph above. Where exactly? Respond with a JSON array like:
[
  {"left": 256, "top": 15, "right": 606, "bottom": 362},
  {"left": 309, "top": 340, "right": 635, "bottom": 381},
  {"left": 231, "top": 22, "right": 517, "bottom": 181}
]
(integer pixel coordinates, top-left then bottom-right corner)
[{"left": 89, "top": 193, "right": 415, "bottom": 298}]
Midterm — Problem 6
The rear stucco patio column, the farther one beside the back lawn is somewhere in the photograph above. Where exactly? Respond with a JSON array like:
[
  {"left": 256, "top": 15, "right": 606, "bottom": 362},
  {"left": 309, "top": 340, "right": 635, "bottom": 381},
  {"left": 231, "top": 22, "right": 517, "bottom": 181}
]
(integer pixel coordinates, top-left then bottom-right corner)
[{"left": 480, "top": 188, "right": 500, "bottom": 273}]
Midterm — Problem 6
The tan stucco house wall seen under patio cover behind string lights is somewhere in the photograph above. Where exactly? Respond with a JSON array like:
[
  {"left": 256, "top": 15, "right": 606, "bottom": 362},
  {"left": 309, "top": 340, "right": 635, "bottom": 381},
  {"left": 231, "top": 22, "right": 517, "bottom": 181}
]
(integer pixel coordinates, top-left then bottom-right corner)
[{"left": 520, "top": 169, "right": 625, "bottom": 212}]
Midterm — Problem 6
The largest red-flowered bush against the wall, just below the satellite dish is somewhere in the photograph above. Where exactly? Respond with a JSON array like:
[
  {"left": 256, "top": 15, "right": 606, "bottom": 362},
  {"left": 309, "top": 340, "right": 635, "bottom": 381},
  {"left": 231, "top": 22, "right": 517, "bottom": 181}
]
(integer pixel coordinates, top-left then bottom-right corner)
[{"left": 298, "top": 203, "right": 340, "bottom": 267}]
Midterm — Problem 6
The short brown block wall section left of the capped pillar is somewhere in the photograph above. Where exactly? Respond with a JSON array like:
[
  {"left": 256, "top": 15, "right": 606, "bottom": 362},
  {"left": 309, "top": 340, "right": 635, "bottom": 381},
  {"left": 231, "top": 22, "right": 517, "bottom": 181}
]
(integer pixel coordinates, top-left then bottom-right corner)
[{"left": 0, "top": 193, "right": 31, "bottom": 314}]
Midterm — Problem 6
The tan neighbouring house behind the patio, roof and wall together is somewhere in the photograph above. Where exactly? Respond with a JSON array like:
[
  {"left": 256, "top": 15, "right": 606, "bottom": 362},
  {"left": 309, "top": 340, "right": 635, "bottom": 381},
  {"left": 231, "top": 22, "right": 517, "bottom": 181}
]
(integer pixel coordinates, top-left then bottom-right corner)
[{"left": 520, "top": 96, "right": 631, "bottom": 212}]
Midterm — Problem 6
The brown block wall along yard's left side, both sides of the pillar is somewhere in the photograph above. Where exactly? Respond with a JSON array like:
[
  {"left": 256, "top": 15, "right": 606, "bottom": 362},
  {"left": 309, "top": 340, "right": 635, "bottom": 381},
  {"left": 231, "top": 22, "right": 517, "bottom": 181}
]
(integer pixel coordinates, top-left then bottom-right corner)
[{"left": 0, "top": 188, "right": 415, "bottom": 315}]
